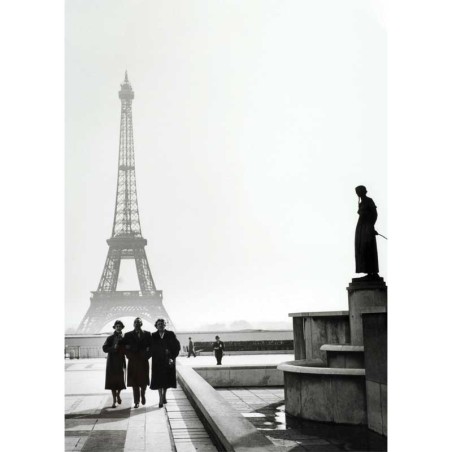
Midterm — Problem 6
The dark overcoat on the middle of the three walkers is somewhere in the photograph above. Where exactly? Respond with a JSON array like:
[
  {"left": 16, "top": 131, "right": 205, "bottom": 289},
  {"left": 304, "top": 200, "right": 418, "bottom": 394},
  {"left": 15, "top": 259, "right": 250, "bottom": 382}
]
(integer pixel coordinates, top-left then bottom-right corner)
[{"left": 124, "top": 330, "right": 151, "bottom": 387}]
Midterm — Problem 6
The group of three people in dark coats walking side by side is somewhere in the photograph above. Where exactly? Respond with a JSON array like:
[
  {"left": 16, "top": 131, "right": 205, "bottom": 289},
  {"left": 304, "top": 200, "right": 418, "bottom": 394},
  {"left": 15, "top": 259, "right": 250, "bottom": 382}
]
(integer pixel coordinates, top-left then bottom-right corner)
[{"left": 102, "top": 317, "right": 180, "bottom": 408}]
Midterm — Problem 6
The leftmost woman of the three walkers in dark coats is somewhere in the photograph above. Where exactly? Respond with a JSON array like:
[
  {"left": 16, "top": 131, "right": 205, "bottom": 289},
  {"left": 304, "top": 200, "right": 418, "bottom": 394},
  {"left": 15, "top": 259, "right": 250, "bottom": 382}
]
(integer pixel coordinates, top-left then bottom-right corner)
[{"left": 102, "top": 320, "right": 126, "bottom": 408}]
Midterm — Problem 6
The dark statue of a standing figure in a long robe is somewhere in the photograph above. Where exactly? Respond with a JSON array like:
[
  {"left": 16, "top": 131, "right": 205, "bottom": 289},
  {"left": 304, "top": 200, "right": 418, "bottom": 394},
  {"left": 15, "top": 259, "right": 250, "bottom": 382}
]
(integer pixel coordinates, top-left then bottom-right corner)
[{"left": 355, "top": 185, "right": 379, "bottom": 278}]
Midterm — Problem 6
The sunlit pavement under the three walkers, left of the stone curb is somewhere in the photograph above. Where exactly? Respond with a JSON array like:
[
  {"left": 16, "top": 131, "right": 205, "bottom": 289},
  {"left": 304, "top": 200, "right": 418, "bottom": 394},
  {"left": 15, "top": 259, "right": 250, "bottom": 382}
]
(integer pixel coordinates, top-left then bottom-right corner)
[{"left": 65, "top": 359, "right": 217, "bottom": 452}]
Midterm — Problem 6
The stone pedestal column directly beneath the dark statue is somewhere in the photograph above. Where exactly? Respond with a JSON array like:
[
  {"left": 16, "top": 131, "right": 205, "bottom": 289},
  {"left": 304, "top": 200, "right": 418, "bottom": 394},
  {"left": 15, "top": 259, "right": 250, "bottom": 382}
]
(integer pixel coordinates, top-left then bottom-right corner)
[{"left": 347, "top": 277, "right": 388, "bottom": 345}]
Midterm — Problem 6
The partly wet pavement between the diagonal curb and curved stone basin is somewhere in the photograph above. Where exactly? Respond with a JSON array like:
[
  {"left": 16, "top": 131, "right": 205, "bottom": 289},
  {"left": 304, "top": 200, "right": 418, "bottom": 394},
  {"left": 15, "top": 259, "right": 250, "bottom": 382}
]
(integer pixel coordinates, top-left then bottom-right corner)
[{"left": 217, "top": 388, "right": 387, "bottom": 452}]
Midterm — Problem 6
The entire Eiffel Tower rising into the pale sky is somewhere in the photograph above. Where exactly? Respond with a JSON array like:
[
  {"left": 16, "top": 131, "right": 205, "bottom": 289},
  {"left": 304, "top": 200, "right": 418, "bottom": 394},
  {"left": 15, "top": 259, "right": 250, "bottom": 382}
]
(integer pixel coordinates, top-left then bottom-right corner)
[{"left": 77, "top": 71, "right": 174, "bottom": 334}]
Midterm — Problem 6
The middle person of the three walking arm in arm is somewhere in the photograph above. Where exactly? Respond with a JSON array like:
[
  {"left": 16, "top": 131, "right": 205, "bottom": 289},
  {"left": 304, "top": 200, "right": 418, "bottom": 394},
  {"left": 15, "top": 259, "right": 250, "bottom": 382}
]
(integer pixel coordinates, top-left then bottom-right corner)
[{"left": 124, "top": 317, "right": 151, "bottom": 408}]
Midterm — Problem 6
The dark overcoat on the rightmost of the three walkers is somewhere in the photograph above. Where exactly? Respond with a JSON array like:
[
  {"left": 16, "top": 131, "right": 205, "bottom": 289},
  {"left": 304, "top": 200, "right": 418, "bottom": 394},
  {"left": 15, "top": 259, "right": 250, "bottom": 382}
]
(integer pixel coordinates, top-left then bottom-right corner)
[{"left": 151, "top": 330, "right": 180, "bottom": 389}]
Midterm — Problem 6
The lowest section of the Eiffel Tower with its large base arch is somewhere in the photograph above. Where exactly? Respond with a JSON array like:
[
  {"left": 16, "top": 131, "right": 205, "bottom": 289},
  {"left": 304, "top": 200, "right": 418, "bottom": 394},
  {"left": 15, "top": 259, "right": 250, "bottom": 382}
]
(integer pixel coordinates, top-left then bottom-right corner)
[{"left": 76, "top": 290, "right": 175, "bottom": 334}]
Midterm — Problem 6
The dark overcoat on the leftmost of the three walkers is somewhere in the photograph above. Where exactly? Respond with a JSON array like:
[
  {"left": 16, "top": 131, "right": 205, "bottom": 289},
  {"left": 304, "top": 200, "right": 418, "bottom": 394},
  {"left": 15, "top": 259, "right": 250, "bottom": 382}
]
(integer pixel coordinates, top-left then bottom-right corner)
[{"left": 102, "top": 333, "right": 126, "bottom": 390}]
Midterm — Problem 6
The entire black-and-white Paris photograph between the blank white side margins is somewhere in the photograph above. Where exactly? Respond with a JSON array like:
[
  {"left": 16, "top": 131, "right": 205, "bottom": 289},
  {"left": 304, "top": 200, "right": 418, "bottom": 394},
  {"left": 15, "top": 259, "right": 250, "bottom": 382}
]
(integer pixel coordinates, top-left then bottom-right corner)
[{"left": 65, "top": 0, "right": 388, "bottom": 451}]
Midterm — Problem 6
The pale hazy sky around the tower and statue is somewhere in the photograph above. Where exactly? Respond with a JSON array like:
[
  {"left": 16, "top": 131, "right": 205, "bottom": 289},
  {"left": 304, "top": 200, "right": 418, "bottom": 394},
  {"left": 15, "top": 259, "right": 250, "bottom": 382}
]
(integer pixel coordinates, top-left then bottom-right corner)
[{"left": 66, "top": 0, "right": 388, "bottom": 330}]
